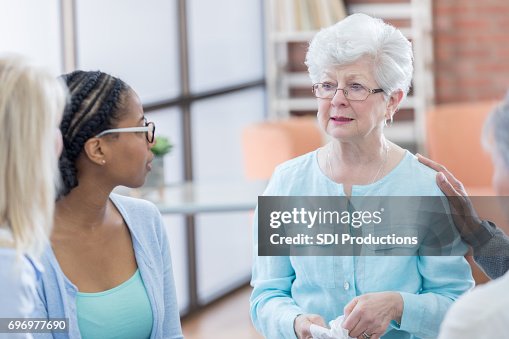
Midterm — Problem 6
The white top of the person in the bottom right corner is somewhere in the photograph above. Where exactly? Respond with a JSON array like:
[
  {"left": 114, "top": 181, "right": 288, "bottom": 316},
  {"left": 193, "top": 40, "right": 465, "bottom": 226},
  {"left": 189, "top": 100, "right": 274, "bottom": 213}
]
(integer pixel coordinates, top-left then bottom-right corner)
[{"left": 439, "top": 274, "right": 509, "bottom": 339}]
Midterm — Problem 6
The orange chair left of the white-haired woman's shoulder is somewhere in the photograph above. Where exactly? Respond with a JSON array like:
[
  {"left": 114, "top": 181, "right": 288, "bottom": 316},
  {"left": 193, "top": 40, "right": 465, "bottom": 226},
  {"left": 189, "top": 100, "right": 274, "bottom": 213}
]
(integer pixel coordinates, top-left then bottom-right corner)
[{"left": 242, "top": 117, "right": 323, "bottom": 179}]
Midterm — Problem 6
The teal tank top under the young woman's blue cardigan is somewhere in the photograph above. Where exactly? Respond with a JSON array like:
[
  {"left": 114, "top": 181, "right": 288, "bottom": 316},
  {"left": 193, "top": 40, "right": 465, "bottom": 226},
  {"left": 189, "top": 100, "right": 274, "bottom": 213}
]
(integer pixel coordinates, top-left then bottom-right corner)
[{"left": 76, "top": 270, "right": 153, "bottom": 339}]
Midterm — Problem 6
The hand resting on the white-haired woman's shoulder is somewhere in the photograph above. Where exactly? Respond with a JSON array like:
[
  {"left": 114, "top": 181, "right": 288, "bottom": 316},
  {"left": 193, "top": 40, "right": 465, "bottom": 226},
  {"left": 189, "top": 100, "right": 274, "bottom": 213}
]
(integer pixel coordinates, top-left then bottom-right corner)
[{"left": 417, "top": 154, "right": 483, "bottom": 245}]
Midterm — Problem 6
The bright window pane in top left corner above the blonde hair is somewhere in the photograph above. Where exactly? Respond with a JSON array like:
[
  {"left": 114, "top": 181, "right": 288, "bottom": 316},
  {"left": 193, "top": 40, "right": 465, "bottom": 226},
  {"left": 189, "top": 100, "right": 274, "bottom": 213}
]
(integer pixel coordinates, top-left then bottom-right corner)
[{"left": 0, "top": 0, "right": 63, "bottom": 76}]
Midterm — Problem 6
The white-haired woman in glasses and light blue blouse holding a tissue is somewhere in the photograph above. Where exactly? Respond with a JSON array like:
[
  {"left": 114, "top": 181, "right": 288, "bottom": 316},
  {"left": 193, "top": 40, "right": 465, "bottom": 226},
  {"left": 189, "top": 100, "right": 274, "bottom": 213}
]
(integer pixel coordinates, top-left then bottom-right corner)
[{"left": 250, "top": 14, "right": 473, "bottom": 339}]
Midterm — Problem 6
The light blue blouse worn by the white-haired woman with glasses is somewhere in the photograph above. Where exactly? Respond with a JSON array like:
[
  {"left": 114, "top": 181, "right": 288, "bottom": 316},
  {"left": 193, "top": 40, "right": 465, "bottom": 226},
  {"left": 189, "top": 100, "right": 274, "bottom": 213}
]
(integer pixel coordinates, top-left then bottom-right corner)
[{"left": 250, "top": 151, "right": 473, "bottom": 339}]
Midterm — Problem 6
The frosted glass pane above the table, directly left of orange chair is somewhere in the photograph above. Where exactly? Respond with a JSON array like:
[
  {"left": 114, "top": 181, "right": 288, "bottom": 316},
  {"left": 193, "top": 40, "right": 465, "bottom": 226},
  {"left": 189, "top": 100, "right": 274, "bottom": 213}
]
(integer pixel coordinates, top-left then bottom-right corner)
[{"left": 191, "top": 88, "right": 265, "bottom": 181}]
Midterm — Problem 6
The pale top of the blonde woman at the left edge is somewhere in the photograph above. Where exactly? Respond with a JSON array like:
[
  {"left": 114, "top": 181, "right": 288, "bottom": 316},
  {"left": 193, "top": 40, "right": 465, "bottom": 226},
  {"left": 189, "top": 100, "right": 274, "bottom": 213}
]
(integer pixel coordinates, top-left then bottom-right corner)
[{"left": 0, "top": 228, "right": 36, "bottom": 339}]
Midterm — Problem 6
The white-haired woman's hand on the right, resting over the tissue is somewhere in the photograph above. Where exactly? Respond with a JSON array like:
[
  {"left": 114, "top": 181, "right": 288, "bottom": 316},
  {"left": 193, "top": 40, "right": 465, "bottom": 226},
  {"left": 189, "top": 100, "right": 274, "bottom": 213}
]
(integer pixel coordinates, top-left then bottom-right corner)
[{"left": 343, "top": 292, "right": 403, "bottom": 339}]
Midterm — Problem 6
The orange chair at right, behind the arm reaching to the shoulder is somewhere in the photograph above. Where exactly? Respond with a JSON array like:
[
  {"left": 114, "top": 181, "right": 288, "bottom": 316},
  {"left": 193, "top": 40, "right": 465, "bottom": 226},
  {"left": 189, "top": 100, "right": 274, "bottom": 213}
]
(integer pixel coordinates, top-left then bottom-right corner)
[{"left": 426, "top": 101, "right": 500, "bottom": 284}]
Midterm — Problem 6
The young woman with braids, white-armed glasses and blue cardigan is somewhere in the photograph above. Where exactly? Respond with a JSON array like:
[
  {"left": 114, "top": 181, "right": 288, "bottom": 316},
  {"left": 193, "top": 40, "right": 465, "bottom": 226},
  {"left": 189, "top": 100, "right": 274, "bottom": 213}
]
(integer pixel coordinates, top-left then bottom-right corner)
[{"left": 32, "top": 71, "right": 182, "bottom": 338}]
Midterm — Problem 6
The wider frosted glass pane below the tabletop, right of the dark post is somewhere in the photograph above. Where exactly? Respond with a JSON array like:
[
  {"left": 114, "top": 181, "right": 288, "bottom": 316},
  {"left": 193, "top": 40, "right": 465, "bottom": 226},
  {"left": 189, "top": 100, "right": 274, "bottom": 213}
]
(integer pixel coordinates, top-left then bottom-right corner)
[{"left": 196, "top": 212, "right": 253, "bottom": 303}]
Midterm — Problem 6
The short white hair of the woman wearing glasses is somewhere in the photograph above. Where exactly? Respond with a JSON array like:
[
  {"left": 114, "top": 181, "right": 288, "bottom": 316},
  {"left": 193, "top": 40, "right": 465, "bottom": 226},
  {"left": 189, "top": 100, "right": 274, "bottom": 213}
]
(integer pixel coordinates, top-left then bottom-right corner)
[{"left": 306, "top": 13, "right": 413, "bottom": 102}]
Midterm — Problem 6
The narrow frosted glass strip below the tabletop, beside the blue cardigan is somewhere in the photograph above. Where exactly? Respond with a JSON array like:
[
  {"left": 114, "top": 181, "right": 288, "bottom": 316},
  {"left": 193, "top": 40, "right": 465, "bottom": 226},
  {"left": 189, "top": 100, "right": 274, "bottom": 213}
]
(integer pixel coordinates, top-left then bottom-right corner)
[{"left": 163, "top": 215, "right": 189, "bottom": 312}]
